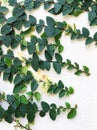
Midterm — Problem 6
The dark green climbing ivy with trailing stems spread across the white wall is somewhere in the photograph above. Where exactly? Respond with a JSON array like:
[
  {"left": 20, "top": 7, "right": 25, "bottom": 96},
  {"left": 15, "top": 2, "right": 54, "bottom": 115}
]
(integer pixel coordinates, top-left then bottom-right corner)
[{"left": 0, "top": 0, "right": 93, "bottom": 130}]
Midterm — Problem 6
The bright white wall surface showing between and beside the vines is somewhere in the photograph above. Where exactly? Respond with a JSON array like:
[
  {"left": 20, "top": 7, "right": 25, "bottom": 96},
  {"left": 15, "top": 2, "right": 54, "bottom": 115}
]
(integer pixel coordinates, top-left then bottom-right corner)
[{"left": 0, "top": 0, "right": 97, "bottom": 130}]
